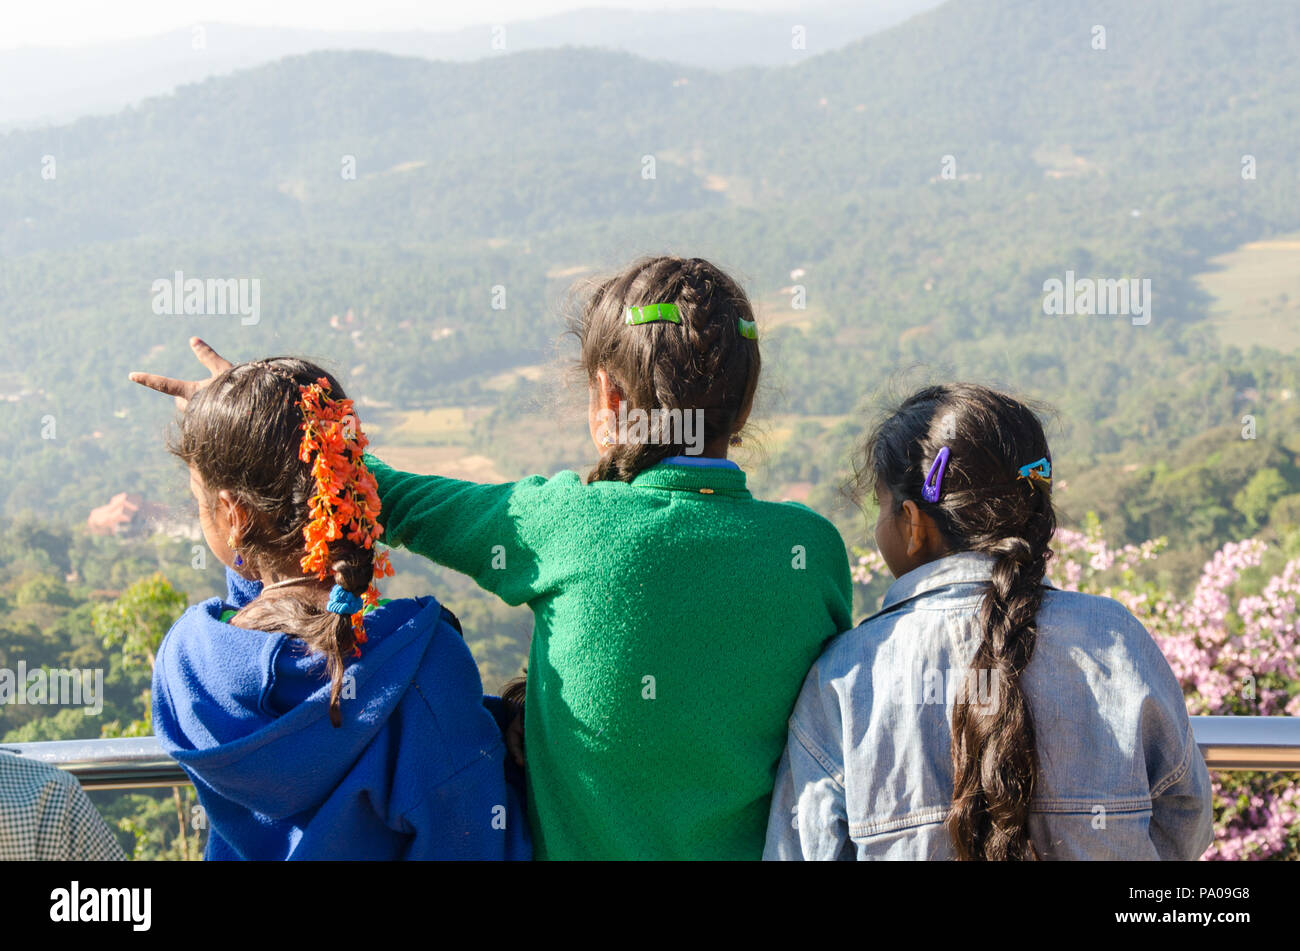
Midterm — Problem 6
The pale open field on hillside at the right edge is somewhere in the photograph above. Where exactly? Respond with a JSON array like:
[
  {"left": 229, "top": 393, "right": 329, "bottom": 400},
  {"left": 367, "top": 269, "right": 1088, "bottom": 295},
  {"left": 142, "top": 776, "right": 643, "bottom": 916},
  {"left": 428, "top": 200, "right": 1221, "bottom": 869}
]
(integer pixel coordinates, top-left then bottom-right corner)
[{"left": 1197, "top": 235, "right": 1300, "bottom": 353}]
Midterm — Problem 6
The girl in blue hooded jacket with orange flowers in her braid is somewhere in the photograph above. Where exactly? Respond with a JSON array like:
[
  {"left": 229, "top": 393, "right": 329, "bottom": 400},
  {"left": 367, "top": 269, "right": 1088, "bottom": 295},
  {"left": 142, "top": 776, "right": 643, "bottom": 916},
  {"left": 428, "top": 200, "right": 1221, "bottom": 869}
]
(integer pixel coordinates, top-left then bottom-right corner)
[{"left": 153, "top": 359, "right": 530, "bottom": 859}]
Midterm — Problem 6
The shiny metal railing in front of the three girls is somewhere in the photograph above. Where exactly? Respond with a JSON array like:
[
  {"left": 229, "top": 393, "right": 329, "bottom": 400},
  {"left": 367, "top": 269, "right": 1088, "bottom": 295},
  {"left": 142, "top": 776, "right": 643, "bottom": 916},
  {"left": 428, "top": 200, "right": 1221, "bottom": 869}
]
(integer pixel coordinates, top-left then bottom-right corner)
[{"left": 0, "top": 717, "right": 1300, "bottom": 789}]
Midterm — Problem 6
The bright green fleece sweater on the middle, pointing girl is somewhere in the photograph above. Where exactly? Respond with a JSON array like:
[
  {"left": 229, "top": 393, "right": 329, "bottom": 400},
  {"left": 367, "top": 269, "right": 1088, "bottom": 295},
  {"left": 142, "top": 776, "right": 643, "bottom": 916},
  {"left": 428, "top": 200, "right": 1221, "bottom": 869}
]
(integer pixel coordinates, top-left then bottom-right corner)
[{"left": 367, "top": 456, "right": 852, "bottom": 859}]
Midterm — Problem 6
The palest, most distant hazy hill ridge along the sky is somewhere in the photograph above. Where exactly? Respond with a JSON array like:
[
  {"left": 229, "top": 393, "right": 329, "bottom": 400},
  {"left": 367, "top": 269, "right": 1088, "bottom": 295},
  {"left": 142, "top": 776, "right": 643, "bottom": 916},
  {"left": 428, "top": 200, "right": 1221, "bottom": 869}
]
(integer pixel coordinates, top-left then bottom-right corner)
[{"left": 0, "top": 0, "right": 940, "bottom": 130}]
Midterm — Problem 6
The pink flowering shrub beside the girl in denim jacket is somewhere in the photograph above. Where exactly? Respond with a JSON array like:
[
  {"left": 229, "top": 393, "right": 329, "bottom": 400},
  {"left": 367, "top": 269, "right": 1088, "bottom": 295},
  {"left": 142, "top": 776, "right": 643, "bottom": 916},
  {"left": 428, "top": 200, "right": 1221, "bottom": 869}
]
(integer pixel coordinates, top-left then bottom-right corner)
[{"left": 853, "top": 518, "right": 1300, "bottom": 859}]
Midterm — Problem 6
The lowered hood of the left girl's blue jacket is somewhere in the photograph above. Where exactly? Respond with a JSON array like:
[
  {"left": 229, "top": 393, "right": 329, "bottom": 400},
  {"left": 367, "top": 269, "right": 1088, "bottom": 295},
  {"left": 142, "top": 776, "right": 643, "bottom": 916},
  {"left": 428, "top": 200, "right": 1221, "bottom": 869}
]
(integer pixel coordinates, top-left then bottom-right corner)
[{"left": 153, "top": 598, "right": 454, "bottom": 818}]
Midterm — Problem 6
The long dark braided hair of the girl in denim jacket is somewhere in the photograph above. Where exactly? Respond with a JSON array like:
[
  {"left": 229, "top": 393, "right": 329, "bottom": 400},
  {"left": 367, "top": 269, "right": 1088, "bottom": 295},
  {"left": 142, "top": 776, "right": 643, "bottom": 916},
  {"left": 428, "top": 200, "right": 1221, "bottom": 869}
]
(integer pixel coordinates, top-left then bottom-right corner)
[{"left": 858, "top": 383, "right": 1056, "bottom": 860}]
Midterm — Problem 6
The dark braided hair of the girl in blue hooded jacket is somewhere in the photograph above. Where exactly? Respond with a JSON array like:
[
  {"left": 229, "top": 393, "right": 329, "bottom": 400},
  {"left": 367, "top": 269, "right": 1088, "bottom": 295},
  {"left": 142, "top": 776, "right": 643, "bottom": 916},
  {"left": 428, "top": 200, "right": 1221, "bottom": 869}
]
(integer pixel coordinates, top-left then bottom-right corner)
[{"left": 169, "top": 357, "right": 374, "bottom": 726}]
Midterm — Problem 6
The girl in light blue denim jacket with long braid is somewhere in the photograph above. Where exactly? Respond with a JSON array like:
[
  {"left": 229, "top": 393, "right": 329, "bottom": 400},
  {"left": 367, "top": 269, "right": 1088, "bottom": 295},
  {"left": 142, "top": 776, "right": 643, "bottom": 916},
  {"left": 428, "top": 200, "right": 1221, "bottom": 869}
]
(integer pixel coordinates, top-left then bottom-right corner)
[{"left": 764, "top": 385, "right": 1213, "bottom": 860}]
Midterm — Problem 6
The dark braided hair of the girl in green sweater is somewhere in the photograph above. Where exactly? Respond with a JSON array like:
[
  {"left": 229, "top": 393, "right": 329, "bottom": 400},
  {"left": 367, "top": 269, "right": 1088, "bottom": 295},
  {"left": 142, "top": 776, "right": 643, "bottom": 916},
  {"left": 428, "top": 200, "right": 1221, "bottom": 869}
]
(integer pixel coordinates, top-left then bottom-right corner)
[{"left": 571, "top": 257, "right": 762, "bottom": 482}]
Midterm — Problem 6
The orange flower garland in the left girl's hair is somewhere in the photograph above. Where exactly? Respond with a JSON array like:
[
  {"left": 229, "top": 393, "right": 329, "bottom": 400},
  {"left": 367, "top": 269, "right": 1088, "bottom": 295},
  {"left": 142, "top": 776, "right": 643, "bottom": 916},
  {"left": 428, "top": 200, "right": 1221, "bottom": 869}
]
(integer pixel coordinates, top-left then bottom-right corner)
[{"left": 298, "top": 377, "right": 393, "bottom": 656}]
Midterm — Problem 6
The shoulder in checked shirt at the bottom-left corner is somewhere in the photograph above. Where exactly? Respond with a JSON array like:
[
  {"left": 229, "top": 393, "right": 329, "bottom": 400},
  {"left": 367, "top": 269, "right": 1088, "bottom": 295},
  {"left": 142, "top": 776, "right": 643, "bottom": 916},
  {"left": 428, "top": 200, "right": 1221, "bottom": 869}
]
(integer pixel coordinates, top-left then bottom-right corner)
[{"left": 0, "top": 751, "right": 126, "bottom": 861}]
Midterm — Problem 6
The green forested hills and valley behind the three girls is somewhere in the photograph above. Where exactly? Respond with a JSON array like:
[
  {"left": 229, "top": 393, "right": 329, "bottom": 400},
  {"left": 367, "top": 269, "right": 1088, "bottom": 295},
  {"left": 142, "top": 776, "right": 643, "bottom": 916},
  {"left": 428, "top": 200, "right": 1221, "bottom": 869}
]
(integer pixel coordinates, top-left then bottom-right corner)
[{"left": 0, "top": 0, "right": 1300, "bottom": 855}]
